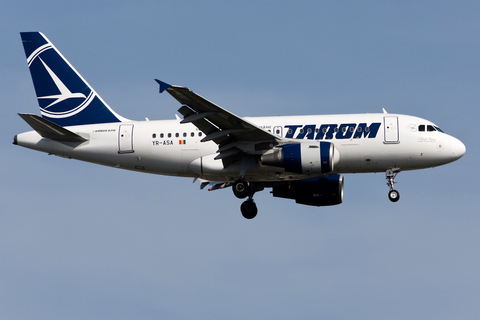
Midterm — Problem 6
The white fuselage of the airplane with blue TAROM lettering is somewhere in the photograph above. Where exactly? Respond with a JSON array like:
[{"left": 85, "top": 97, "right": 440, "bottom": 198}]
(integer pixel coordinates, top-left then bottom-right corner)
[{"left": 16, "top": 113, "right": 465, "bottom": 181}]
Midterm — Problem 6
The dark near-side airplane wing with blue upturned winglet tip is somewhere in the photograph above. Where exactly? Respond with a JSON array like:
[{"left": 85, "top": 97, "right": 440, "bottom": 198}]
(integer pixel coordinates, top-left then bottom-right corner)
[{"left": 155, "top": 79, "right": 281, "bottom": 167}]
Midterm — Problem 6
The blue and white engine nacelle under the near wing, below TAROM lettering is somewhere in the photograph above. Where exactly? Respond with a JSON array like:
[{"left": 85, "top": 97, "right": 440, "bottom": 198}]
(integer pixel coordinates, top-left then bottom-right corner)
[{"left": 261, "top": 141, "right": 339, "bottom": 174}]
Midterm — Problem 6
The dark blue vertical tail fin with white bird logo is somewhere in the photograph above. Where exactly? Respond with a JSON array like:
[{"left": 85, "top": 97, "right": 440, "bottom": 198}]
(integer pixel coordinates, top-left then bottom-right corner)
[{"left": 20, "top": 32, "right": 127, "bottom": 127}]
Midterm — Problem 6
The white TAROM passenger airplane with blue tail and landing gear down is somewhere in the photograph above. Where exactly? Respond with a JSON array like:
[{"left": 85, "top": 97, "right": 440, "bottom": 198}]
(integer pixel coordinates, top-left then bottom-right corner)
[{"left": 13, "top": 32, "right": 466, "bottom": 219}]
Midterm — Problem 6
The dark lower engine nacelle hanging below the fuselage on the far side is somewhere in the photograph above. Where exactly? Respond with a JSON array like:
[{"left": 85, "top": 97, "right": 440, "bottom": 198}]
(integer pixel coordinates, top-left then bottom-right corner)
[{"left": 272, "top": 174, "right": 343, "bottom": 207}]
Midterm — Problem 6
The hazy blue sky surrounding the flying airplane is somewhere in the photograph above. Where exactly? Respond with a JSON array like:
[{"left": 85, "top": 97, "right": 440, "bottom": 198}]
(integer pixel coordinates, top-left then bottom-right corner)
[{"left": 0, "top": 0, "right": 480, "bottom": 320}]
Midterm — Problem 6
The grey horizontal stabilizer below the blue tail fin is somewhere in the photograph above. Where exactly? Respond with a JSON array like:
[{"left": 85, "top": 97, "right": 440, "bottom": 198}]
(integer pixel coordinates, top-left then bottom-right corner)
[{"left": 18, "top": 113, "right": 87, "bottom": 142}]
